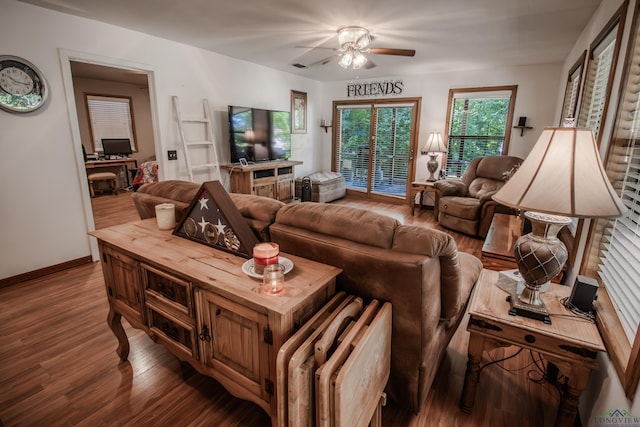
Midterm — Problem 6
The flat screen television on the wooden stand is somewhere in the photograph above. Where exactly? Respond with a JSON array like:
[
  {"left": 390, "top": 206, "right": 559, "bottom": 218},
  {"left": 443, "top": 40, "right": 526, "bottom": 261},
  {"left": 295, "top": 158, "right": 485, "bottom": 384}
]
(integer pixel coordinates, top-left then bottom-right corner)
[{"left": 229, "top": 105, "right": 291, "bottom": 163}]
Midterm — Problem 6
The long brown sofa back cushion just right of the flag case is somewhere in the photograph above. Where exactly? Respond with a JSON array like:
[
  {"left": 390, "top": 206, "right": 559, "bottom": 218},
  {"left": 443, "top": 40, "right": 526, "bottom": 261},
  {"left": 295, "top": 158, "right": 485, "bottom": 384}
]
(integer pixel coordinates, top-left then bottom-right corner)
[{"left": 276, "top": 202, "right": 400, "bottom": 249}]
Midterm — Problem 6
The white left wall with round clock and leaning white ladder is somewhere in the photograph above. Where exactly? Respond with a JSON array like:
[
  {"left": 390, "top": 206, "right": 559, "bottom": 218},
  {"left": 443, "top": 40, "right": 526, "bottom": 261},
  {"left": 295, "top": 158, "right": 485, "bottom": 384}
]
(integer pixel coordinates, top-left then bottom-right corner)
[{"left": 0, "top": 0, "right": 321, "bottom": 278}]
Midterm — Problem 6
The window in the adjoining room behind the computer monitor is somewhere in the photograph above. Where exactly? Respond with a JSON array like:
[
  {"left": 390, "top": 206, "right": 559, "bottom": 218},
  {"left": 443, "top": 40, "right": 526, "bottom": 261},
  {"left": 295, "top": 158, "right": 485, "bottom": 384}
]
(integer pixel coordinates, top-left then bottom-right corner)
[{"left": 85, "top": 95, "right": 136, "bottom": 152}]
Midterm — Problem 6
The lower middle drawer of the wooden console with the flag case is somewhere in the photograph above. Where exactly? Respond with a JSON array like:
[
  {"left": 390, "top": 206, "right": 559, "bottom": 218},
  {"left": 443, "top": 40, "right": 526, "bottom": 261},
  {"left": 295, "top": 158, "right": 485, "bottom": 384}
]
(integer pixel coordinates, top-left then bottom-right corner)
[{"left": 146, "top": 301, "right": 198, "bottom": 359}]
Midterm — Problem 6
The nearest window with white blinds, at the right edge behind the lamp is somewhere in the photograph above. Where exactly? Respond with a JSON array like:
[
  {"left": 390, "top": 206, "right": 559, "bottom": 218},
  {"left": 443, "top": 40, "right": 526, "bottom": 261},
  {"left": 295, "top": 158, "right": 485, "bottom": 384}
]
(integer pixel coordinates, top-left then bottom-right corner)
[{"left": 580, "top": 0, "right": 640, "bottom": 399}]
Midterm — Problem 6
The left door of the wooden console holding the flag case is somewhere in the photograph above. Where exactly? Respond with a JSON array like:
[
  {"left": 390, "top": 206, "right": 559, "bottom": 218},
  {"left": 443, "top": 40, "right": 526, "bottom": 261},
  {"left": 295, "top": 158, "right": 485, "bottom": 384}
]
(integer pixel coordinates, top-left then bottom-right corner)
[{"left": 100, "top": 245, "right": 144, "bottom": 326}]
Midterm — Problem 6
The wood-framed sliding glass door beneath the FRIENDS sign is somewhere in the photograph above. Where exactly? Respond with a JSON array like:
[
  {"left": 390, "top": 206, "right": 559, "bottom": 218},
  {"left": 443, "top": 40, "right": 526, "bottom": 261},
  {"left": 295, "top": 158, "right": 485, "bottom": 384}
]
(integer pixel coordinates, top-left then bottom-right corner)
[{"left": 332, "top": 98, "right": 420, "bottom": 200}]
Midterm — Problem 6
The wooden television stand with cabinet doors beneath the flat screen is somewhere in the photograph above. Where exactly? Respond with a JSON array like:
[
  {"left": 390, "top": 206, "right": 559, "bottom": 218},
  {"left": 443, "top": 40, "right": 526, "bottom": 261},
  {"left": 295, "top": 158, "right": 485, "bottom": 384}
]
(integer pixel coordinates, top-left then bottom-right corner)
[{"left": 221, "top": 160, "right": 302, "bottom": 202}]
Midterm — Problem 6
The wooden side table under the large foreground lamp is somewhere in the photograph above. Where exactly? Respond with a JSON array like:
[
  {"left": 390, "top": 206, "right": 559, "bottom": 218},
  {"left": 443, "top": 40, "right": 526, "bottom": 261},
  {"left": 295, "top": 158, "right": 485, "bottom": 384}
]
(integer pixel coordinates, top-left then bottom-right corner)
[{"left": 460, "top": 270, "right": 605, "bottom": 427}]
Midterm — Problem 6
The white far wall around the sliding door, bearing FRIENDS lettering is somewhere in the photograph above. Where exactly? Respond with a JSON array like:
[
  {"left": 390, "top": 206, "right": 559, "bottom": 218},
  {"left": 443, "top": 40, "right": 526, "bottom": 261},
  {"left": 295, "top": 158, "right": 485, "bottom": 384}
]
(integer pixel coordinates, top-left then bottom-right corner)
[{"left": 314, "top": 63, "right": 562, "bottom": 179}]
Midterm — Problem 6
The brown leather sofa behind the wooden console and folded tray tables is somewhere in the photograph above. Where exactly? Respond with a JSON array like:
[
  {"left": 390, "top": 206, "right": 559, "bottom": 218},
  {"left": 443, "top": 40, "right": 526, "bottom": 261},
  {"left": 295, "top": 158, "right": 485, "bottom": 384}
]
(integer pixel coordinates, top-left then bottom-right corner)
[{"left": 134, "top": 182, "right": 482, "bottom": 412}]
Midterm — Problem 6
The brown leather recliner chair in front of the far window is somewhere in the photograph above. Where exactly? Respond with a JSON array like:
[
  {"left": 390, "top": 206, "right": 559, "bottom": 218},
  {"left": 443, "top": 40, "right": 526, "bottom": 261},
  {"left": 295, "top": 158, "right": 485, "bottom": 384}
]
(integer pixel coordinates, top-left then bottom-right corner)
[{"left": 433, "top": 156, "right": 522, "bottom": 238}]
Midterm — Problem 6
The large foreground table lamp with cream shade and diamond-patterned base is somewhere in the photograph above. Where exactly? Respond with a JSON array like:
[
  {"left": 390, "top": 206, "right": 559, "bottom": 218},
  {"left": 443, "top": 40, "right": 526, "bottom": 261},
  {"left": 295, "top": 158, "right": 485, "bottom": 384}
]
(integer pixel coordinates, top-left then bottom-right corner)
[{"left": 493, "top": 127, "right": 627, "bottom": 324}]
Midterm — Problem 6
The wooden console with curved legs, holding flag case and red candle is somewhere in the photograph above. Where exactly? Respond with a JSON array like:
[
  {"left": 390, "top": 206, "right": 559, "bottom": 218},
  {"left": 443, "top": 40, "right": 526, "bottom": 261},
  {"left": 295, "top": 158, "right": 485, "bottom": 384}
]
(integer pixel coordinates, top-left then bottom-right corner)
[{"left": 90, "top": 218, "right": 341, "bottom": 426}]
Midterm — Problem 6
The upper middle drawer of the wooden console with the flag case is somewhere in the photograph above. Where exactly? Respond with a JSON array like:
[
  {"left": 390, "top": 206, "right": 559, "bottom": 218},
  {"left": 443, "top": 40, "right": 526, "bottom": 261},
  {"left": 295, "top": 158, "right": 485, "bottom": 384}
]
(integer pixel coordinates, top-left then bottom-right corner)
[{"left": 141, "top": 264, "right": 193, "bottom": 317}]
